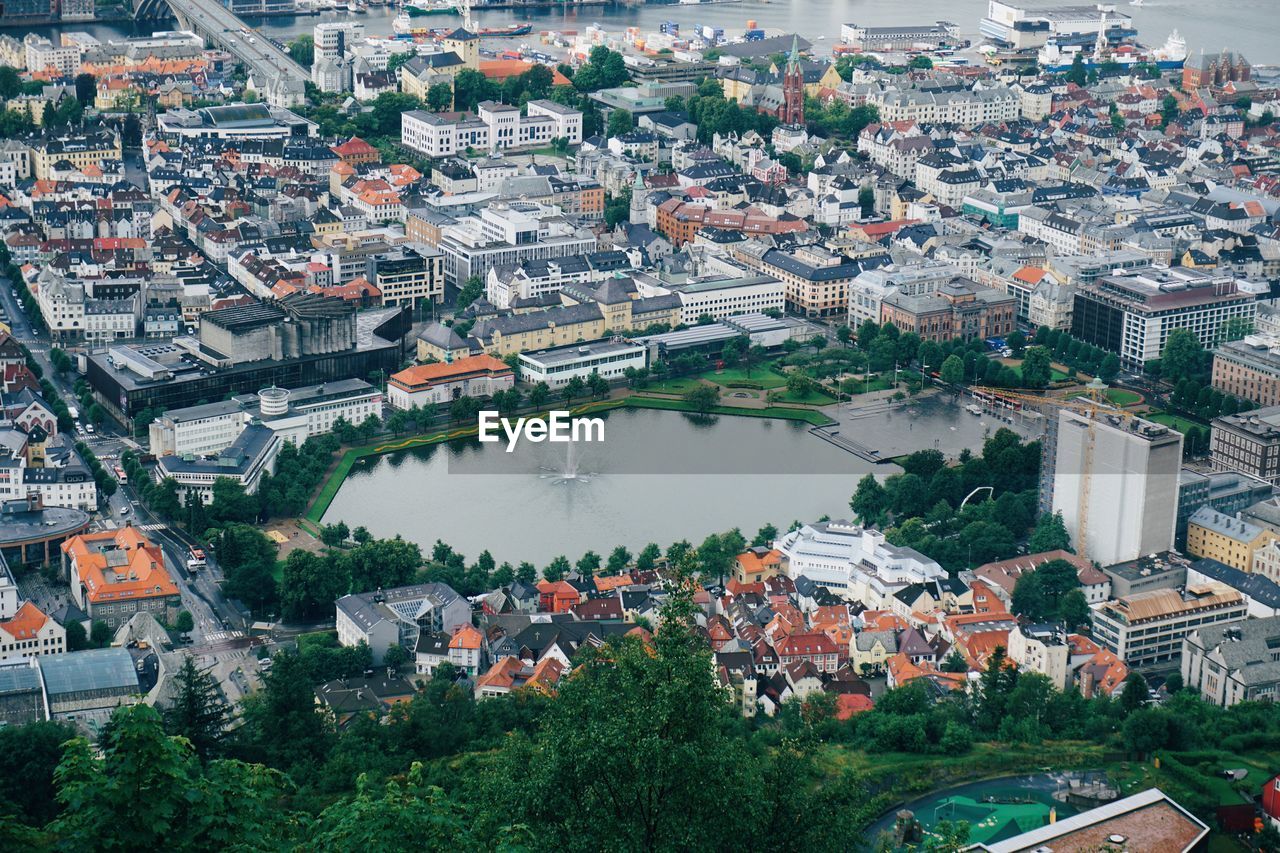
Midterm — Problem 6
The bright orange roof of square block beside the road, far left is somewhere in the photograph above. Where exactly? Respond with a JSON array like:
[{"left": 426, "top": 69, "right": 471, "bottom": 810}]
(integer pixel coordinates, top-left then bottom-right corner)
[{"left": 63, "top": 525, "right": 178, "bottom": 605}]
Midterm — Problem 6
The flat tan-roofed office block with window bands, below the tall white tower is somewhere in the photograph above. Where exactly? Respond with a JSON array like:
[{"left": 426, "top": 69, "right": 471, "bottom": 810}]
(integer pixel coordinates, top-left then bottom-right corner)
[{"left": 1093, "top": 583, "right": 1247, "bottom": 667}]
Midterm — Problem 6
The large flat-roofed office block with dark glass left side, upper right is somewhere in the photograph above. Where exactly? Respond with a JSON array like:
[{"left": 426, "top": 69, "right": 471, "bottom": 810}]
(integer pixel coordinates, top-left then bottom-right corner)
[{"left": 1071, "top": 268, "right": 1257, "bottom": 370}]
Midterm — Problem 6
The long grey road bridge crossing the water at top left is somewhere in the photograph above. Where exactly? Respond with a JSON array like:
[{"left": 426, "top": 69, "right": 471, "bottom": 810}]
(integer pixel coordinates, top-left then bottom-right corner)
[{"left": 133, "top": 0, "right": 311, "bottom": 102}]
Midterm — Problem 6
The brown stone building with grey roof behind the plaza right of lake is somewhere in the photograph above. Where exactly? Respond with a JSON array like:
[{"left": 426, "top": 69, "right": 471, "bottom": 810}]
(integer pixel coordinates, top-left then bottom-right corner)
[{"left": 881, "top": 277, "right": 1018, "bottom": 341}]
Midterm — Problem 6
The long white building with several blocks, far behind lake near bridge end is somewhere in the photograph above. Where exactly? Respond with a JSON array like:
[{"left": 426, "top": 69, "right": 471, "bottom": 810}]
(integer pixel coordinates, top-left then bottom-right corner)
[{"left": 401, "top": 101, "right": 582, "bottom": 158}]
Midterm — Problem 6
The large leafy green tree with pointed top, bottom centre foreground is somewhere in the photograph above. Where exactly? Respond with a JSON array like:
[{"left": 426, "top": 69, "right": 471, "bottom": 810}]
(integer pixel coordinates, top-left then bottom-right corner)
[{"left": 485, "top": 589, "right": 753, "bottom": 850}]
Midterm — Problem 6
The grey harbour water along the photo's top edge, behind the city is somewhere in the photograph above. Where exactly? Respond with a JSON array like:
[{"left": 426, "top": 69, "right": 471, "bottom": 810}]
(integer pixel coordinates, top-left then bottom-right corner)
[{"left": 23, "top": 0, "right": 1280, "bottom": 64}]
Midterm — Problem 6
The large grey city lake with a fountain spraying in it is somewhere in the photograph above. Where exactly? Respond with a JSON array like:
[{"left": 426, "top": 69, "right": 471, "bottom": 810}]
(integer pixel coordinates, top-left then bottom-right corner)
[{"left": 324, "top": 410, "right": 900, "bottom": 566}]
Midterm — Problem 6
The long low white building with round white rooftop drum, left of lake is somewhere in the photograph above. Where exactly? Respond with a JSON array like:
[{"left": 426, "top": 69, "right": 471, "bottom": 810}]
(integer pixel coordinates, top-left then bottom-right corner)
[{"left": 148, "top": 379, "right": 383, "bottom": 456}]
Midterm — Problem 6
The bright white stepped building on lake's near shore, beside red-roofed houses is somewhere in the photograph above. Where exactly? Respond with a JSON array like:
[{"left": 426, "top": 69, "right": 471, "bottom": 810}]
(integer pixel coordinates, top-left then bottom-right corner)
[{"left": 773, "top": 521, "right": 947, "bottom": 610}]
